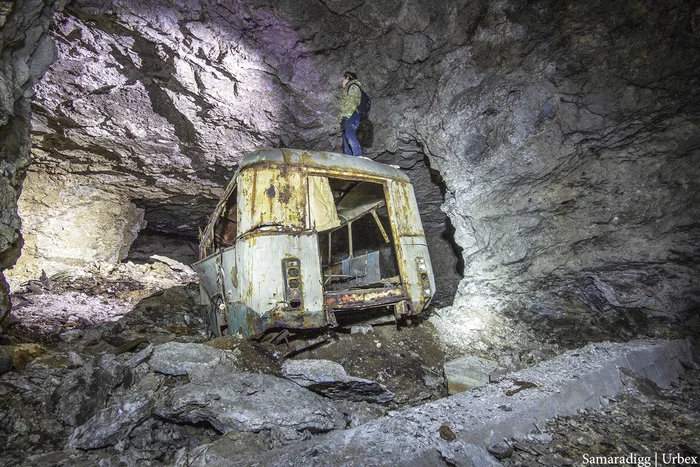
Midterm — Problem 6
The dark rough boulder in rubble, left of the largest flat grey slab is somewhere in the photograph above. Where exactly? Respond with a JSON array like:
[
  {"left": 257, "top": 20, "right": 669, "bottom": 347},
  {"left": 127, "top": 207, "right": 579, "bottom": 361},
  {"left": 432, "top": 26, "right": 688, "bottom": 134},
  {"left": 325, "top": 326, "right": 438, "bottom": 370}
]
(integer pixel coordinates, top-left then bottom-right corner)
[{"left": 51, "top": 354, "right": 126, "bottom": 426}]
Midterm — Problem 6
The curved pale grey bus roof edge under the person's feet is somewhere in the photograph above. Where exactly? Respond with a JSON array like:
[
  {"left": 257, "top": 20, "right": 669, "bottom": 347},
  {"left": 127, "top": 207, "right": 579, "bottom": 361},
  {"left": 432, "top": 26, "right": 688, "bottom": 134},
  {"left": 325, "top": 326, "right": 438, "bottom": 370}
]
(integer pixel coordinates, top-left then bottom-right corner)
[{"left": 239, "top": 149, "right": 409, "bottom": 182}]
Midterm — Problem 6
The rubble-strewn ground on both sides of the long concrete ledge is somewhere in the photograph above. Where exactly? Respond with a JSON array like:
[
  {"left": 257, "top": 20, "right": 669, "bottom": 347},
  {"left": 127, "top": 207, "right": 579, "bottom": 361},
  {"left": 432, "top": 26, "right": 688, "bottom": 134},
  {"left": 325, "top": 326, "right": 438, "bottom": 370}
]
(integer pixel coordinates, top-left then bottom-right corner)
[{"left": 0, "top": 247, "right": 700, "bottom": 466}]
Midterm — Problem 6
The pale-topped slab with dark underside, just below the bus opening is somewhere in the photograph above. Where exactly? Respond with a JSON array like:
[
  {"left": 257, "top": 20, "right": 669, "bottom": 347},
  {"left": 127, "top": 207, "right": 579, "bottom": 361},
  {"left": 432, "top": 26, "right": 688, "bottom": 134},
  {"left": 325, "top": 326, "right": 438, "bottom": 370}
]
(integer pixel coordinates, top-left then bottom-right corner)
[{"left": 282, "top": 359, "right": 394, "bottom": 404}]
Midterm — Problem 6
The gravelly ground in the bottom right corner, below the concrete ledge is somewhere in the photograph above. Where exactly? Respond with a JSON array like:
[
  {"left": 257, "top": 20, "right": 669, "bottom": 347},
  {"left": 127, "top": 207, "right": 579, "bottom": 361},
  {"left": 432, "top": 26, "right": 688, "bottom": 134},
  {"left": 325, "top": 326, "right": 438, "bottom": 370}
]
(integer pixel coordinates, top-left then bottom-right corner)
[{"left": 502, "top": 369, "right": 700, "bottom": 466}]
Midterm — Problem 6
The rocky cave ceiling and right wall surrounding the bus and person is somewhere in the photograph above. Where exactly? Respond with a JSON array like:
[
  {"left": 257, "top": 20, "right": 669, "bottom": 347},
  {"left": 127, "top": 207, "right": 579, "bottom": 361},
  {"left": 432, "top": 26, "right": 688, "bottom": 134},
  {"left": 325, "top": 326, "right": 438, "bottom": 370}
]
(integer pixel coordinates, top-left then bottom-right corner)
[{"left": 0, "top": 0, "right": 700, "bottom": 332}]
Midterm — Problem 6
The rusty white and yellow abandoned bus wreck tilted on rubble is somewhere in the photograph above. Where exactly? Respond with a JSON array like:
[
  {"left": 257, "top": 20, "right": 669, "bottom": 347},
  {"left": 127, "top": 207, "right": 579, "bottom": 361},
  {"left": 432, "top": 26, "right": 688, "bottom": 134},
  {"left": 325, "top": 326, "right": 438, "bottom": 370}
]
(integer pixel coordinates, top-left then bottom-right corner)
[{"left": 193, "top": 149, "right": 435, "bottom": 337}]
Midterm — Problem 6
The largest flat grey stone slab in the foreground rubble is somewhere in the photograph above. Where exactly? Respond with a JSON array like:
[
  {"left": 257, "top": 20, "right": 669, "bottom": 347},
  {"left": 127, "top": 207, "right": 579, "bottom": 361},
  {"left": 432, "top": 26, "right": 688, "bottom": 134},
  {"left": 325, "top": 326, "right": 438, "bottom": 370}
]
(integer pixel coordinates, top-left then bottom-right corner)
[{"left": 154, "top": 372, "right": 345, "bottom": 433}]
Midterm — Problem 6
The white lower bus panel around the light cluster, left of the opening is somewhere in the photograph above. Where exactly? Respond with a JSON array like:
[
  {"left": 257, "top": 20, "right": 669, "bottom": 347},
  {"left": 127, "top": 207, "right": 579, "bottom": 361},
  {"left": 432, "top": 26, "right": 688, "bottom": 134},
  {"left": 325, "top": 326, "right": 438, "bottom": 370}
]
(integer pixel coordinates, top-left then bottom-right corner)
[{"left": 236, "top": 233, "right": 326, "bottom": 329}]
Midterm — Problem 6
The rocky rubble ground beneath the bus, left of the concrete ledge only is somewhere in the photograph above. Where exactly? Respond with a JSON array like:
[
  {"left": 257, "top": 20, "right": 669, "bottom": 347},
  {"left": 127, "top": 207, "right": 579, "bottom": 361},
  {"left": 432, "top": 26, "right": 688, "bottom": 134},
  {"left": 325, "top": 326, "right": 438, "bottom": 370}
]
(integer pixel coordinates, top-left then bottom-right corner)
[{"left": 0, "top": 247, "right": 446, "bottom": 466}]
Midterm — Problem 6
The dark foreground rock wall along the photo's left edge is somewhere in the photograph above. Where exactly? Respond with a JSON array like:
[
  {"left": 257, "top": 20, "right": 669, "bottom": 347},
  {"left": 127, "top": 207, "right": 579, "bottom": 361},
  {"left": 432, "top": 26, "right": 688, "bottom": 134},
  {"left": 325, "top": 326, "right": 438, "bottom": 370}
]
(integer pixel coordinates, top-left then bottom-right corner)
[{"left": 0, "top": 0, "right": 66, "bottom": 332}]
